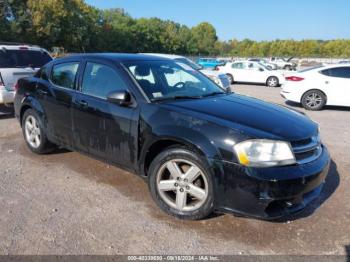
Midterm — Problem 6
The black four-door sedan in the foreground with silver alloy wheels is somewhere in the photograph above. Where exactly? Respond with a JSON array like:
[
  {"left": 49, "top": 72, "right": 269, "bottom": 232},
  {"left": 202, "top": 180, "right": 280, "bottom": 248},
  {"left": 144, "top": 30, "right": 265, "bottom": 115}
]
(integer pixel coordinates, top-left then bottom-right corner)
[{"left": 15, "top": 54, "right": 330, "bottom": 219}]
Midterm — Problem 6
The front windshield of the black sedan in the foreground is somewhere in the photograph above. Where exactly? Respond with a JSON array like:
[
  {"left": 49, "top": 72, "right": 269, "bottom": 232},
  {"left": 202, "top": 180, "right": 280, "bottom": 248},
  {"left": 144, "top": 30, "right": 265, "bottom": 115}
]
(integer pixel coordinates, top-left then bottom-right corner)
[{"left": 124, "top": 61, "right": 225, "bottom": 101}]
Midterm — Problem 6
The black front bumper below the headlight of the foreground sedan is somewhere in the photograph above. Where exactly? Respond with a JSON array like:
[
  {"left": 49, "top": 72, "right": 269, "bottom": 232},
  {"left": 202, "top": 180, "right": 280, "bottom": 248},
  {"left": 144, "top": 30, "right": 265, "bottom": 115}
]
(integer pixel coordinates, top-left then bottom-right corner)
[{"left": 213, "top": 147, "right": 330, "bottom": 219}]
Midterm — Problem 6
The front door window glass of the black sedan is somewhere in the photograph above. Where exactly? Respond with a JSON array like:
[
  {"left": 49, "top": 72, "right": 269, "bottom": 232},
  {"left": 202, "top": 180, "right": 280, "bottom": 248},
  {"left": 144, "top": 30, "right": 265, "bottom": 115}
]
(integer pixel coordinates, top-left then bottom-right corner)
[{"left": 81, "top": 62, "right": 127, "bottom": 98}]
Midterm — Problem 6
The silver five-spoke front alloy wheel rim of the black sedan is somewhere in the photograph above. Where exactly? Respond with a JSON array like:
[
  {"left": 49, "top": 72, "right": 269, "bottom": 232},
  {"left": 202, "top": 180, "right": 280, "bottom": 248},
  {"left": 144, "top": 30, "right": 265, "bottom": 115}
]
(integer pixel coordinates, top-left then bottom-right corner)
[{"left": 157, "top": 159, "right": 208, "bottom": 211}]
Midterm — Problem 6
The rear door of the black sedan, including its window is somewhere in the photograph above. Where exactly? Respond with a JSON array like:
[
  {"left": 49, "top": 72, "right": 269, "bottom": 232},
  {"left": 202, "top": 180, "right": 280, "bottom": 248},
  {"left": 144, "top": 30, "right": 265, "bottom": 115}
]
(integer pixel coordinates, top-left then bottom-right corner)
[{"left": 35, "top": 61, "right": 80, "bottom": 147}]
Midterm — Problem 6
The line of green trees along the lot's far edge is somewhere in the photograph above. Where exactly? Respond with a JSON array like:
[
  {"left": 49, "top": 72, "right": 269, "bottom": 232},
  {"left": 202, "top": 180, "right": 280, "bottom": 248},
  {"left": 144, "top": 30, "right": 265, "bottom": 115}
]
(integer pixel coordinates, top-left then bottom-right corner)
[{"left": 0, "top": 0, "right": 350, "bottom": 58}]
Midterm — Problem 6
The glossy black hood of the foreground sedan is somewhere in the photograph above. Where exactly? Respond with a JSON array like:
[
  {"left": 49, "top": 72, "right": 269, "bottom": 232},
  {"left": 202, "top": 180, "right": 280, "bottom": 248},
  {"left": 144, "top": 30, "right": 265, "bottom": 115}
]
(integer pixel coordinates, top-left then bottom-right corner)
[{"left": 162, "top": 94, "right": 318, "bottom": 141}]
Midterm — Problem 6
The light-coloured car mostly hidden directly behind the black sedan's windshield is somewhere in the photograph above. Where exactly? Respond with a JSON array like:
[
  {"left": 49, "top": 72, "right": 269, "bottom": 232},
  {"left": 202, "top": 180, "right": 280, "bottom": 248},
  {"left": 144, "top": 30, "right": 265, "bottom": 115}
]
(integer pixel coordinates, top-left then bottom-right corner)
[{"left": 147, "top": 53, "right": 231, "bottom": 90}]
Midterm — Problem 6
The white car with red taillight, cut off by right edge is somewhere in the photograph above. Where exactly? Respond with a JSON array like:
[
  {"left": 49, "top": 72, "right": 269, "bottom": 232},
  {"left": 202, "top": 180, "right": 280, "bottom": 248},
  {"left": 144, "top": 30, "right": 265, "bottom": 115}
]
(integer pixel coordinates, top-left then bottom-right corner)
[{"left": 281, "top": 64, "right": 350, "bottom": 110}]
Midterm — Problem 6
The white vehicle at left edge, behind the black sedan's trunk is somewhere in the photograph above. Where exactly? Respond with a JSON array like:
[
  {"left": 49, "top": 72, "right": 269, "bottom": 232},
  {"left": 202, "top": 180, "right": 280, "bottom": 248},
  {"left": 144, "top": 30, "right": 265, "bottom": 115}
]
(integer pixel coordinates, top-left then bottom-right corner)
[{"left": 0, "top": 42, "right": 52, "bottom": 104}]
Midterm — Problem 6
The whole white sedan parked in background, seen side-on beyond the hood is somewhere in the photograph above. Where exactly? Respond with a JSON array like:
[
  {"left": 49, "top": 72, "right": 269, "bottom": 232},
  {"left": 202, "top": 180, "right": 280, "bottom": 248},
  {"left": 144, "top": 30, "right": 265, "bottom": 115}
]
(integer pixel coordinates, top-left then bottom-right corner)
[{"left": 217, "top": 61, "right": 284, "bottom": 87}]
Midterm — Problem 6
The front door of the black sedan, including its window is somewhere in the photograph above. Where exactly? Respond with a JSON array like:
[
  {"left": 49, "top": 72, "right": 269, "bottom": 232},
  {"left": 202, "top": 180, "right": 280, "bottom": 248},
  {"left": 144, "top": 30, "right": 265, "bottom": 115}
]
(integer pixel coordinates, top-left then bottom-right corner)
[{"left": 72, "top": 60, "right": 138, "bottom": 166}]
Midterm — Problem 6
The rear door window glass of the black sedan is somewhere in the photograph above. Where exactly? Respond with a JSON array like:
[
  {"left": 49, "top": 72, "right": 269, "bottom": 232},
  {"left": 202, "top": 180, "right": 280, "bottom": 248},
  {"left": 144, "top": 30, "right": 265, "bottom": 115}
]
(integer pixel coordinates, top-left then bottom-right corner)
[{"left": 51, "top": 62, "right": 79, "bottom": 89}]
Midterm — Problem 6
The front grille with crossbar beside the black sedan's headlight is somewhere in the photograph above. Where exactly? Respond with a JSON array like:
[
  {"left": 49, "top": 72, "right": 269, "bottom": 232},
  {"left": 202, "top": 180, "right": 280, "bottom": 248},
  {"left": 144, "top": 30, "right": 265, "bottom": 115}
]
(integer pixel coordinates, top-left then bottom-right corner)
[{"left": 291, "top": 135, "right": 322, "bottom": 164}]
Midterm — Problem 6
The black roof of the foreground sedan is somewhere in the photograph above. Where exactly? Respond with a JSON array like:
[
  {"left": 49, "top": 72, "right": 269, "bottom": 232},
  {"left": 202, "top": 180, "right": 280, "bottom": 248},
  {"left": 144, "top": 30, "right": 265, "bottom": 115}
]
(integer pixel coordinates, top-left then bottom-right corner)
[{"left": 55, "top": 53, "right": 170, "bottom": 62}]
